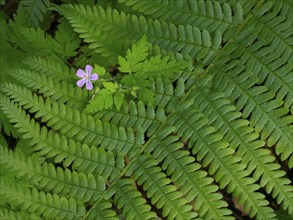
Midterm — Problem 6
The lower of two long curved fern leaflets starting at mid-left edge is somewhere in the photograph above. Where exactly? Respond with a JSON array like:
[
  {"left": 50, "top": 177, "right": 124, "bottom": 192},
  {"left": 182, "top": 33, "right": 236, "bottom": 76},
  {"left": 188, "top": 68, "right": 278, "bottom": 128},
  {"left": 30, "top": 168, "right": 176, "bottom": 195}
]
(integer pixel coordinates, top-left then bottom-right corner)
[{"left": 0, "top": 96, "right": 124, "bottom": 179}]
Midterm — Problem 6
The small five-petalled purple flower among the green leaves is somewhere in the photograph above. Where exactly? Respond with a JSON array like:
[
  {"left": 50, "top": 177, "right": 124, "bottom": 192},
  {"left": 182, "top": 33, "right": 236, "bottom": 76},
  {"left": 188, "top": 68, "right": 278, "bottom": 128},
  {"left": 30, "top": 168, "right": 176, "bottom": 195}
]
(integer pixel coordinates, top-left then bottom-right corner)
[{"left": 76, "top": 65, "right": 99, "bottom": 90}]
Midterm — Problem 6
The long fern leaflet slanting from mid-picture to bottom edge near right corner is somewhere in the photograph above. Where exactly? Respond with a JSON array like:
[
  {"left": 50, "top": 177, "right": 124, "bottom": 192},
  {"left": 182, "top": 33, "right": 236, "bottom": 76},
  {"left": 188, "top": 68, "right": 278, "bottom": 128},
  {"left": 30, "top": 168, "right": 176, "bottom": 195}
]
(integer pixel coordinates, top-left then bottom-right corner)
[{"left": 167, "top": 95, "right": 275, "bottom": 219}]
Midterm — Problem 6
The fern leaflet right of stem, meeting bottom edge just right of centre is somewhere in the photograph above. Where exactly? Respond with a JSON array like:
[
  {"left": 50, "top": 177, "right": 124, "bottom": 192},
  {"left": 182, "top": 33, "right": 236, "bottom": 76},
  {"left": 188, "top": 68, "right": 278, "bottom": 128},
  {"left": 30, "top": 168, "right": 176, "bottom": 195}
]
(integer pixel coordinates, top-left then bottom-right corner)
[{"left": 126, "top": 154, "right": 198, "bottom": 219}]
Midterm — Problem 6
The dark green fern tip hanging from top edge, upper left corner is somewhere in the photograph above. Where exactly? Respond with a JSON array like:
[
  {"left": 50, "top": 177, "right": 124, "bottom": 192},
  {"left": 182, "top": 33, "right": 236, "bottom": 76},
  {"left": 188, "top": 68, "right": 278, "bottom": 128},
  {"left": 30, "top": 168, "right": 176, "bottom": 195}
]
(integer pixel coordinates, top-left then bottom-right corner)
[{"left": 20, "top": 0, "right": 51, "bottom": 27}]
